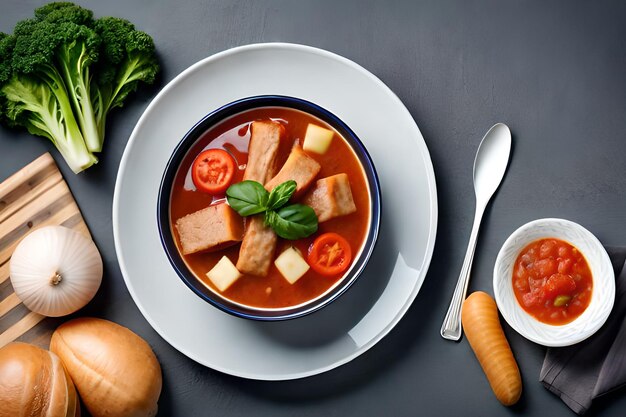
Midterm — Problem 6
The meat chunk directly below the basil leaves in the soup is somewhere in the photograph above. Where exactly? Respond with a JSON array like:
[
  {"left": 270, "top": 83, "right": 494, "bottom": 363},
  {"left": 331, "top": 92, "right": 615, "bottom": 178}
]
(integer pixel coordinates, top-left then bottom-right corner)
[{"left": 237, "top": 214, "right": 278, "bottom": 277}]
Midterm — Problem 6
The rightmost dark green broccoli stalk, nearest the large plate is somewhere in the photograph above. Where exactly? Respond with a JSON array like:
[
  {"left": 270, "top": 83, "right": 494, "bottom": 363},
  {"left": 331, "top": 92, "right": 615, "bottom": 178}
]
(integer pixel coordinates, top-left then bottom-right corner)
[{"left": 92, "top": 17, "right": 159, "bottom": 145}]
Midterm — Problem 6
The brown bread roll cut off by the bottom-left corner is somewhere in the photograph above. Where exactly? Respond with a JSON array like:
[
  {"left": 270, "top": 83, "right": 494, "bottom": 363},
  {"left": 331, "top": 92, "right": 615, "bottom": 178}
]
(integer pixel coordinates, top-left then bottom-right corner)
[{"left": 0, "top": 342, "right": 80, "bottom": 417}]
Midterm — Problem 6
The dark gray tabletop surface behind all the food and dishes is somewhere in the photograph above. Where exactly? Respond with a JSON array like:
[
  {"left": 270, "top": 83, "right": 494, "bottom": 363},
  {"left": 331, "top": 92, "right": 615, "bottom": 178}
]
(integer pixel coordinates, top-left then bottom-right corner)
[{"left": 0, "top": 0, "right": 626, "bottom": 417}]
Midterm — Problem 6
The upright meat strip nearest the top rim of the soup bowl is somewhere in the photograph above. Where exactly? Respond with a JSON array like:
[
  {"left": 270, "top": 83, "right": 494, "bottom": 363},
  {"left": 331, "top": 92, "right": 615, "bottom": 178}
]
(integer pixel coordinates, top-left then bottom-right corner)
[{"left": 243, "top": 121, "right": 285, "bottom": 184}]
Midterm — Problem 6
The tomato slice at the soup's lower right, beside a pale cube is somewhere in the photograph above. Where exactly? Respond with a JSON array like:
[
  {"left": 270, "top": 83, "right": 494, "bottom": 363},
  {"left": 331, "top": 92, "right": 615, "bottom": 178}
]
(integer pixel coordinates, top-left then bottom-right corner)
[{"left": 307, "top": 233, "right": 352, "bottom": 276}]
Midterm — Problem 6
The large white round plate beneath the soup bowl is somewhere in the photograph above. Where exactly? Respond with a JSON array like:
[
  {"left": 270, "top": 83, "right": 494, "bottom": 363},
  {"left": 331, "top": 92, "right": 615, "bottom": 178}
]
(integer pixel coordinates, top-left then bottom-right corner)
[{"left": 113, "top": 43, "right": 437, "bottom": 380}]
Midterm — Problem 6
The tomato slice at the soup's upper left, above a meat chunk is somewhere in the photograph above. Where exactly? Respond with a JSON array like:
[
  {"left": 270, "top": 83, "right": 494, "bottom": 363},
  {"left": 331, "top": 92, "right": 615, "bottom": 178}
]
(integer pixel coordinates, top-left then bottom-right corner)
[{"left": 191, "top": 149, "right": 235, "bottom": 194}]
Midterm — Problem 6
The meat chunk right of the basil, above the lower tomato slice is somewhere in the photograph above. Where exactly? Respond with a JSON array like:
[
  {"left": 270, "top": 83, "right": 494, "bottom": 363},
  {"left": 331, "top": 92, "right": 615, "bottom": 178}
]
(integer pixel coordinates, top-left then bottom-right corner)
[{"left": 302, "top": 173, "right": 356, "bottom": 223}]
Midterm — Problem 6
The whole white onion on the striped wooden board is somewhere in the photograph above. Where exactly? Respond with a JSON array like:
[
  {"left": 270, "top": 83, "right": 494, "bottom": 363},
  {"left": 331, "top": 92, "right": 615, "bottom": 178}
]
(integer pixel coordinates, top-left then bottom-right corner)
[{"left": 9, "top": 226, "right": 102, "bottom": 317}]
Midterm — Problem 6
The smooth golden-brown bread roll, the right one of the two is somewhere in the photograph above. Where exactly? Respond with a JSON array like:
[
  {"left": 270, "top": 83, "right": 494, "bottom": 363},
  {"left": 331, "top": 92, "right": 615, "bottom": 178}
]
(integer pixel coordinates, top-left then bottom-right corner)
[{"left": 50, "top": 318, "right": 162, "bottom": 417}]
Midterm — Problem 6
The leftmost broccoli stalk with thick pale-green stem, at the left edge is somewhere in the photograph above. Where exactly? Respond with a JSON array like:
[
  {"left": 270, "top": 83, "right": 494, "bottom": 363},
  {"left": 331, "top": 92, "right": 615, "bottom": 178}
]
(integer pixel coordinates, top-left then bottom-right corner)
[{"left": 0, "top": 20, "right": 98, "bottom": 172}]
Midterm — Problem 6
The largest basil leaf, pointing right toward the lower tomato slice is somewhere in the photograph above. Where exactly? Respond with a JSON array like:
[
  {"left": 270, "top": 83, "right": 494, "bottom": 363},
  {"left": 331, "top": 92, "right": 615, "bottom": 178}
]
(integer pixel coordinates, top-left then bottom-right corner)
[{"left": 265, "top": 204, "right": 317, "bottom": 240}]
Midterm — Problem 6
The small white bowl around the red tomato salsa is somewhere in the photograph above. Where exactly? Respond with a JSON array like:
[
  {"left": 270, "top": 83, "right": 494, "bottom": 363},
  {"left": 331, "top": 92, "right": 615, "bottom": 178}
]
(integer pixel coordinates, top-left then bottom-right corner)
[{"left": 493, "top": 219, "right": 615, "bottom": 346}]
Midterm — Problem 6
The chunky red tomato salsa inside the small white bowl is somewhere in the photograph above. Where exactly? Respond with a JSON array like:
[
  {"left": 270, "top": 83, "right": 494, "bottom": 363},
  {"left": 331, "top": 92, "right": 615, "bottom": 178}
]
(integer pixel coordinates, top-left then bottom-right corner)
[{"left": 513, "top": 239, "right": 593, "bottom": 325}]
